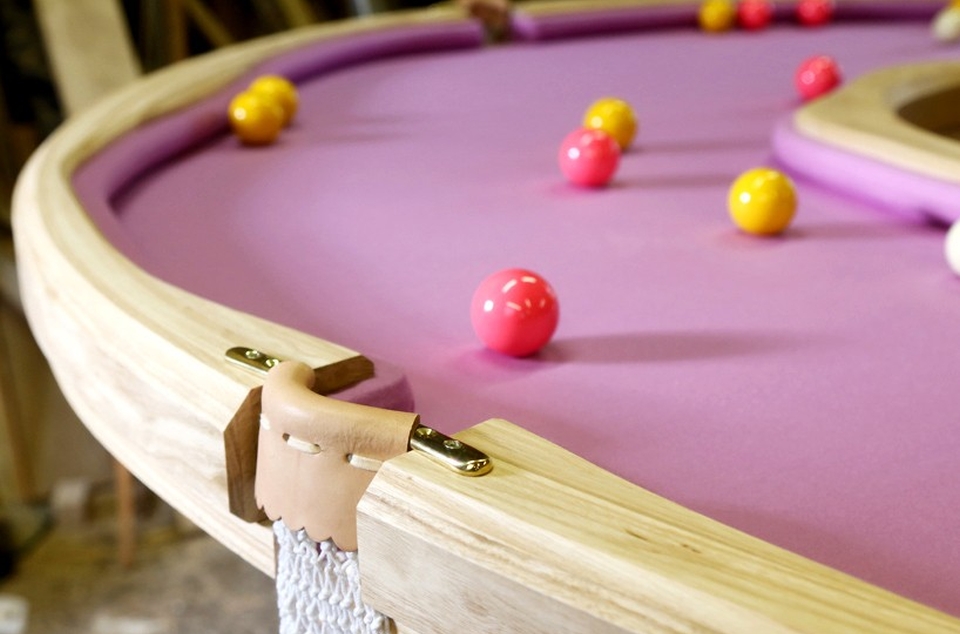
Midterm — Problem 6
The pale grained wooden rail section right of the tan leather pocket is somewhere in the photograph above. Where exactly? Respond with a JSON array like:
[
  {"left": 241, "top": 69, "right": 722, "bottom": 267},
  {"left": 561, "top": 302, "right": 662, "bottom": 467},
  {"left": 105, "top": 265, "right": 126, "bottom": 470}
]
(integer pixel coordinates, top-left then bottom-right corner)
[{"left": 359, "top": 420, "right": 960, "bottom": 634}]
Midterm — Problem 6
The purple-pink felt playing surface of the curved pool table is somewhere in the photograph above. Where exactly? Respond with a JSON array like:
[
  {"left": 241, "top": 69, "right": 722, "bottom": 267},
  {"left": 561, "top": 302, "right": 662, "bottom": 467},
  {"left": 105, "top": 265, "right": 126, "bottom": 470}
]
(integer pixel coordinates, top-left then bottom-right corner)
[{"left": 77, "top": 12, "right": 960, "bottom": 615}]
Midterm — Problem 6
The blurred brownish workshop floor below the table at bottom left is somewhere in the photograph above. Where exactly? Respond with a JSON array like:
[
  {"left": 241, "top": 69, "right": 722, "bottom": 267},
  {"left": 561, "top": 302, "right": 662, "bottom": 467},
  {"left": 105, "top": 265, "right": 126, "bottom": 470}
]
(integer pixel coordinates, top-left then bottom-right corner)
[{"left": 0, "top": 508, "right": 278, "bottom": 634}]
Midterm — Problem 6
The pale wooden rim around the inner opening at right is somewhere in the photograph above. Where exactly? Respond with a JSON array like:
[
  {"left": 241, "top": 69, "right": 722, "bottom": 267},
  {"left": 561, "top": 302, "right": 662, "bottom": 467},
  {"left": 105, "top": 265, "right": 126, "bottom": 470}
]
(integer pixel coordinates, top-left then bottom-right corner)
[{"left": 793, "top": 61, "right": 960, "bottom": 183}]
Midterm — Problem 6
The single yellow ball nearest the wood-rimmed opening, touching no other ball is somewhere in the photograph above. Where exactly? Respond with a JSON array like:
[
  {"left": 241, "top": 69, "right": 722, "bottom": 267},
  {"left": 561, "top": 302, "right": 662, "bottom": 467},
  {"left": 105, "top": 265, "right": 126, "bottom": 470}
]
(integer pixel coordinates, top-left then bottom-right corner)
[{"left": 727, "top": 167, "right": 797, "bottom": 236}]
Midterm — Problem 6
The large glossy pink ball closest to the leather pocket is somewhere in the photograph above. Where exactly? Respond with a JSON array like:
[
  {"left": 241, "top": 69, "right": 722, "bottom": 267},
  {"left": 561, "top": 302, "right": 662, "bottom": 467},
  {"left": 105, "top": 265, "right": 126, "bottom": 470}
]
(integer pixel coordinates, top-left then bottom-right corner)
[{"left": 470, "top": 269, "right": 560, "bottom": 357}]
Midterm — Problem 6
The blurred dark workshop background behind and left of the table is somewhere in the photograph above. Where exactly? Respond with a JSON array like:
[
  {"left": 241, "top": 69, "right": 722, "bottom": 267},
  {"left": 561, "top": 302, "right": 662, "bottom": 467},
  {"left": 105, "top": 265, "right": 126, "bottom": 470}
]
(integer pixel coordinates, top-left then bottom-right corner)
[{"left": 0, "top": 0, "right": 442, "bottom": 634}]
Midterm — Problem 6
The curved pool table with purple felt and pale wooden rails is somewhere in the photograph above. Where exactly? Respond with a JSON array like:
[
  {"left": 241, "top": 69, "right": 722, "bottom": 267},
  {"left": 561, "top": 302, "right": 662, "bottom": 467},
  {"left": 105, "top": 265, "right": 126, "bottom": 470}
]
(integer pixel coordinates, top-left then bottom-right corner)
[{"left": 14, "top": 0, "right": 960, "bottom": 633}]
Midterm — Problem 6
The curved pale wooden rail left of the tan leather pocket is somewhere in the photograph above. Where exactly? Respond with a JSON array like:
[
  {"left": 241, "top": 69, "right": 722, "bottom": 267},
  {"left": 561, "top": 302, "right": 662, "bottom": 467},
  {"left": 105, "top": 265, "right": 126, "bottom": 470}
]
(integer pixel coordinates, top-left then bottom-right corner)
[{"left": 13, "top": 10, "right": 478, "bottom": 574}]
